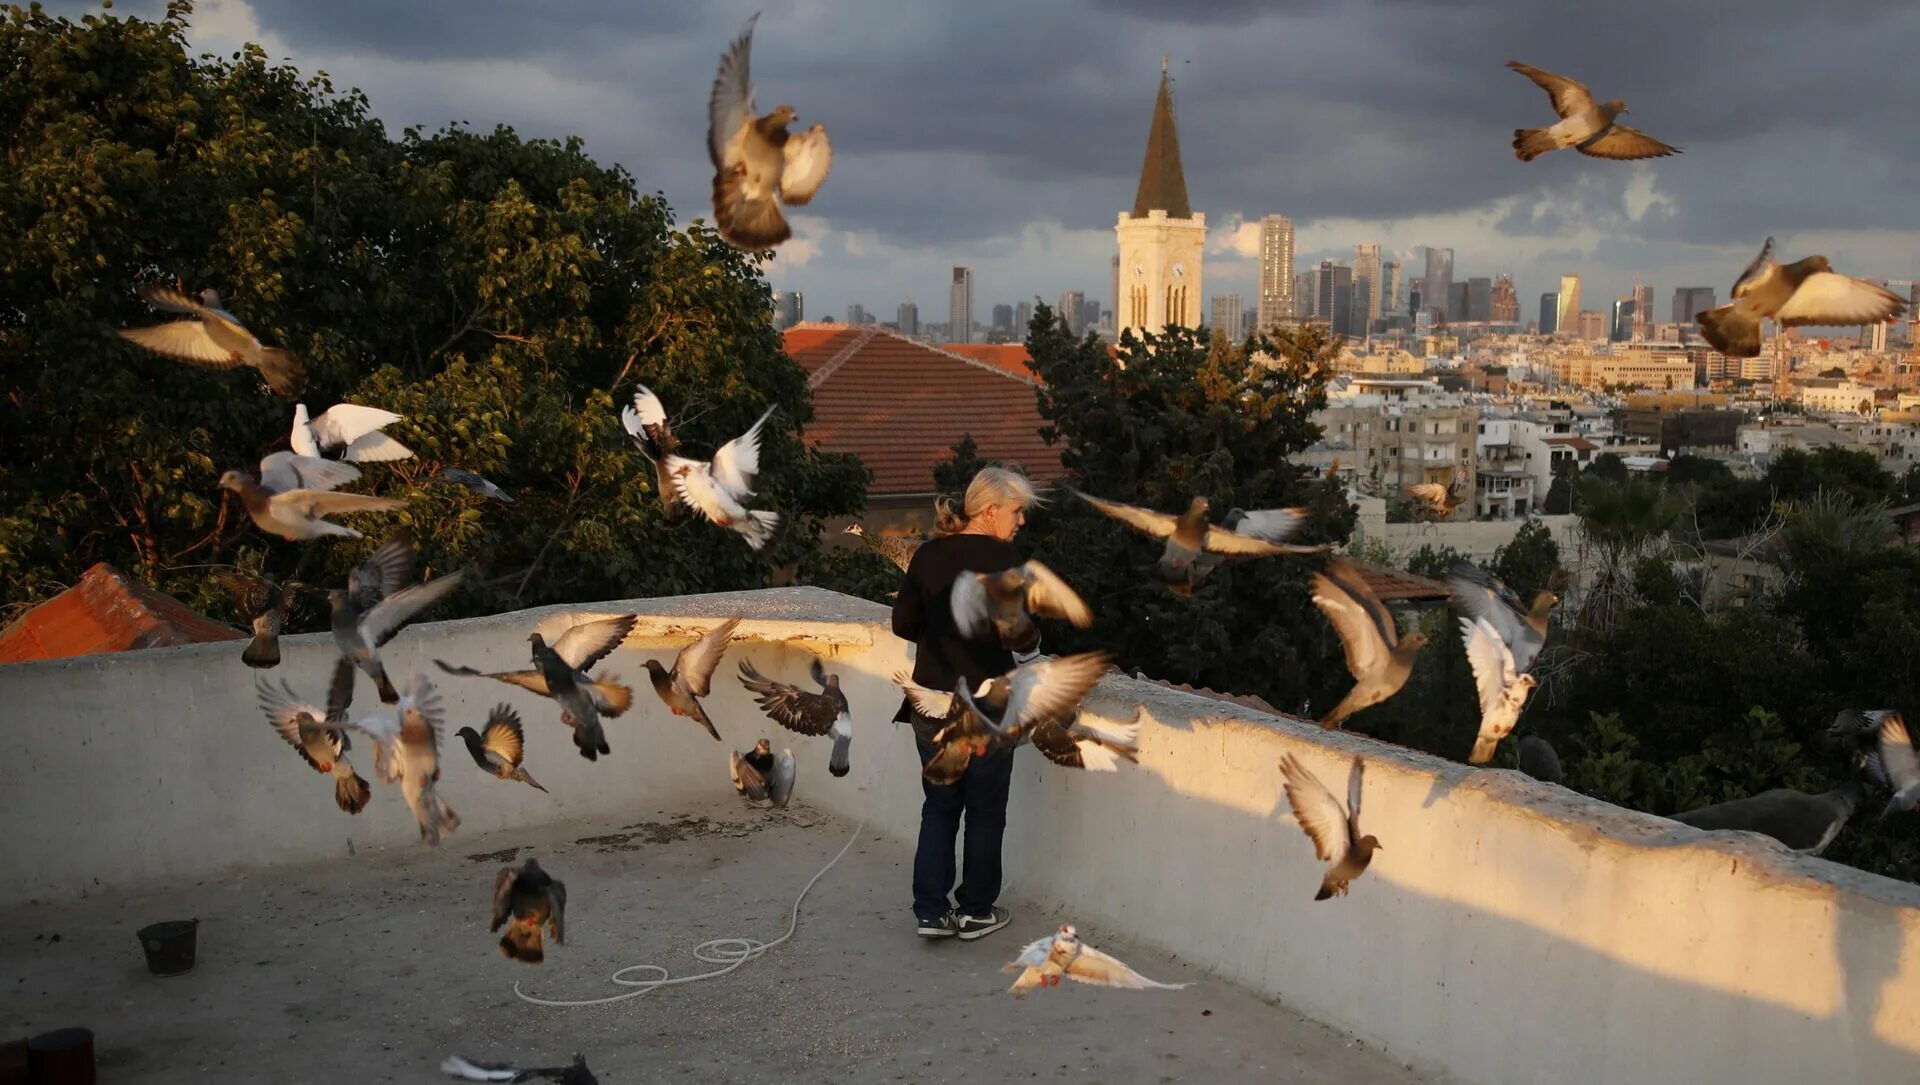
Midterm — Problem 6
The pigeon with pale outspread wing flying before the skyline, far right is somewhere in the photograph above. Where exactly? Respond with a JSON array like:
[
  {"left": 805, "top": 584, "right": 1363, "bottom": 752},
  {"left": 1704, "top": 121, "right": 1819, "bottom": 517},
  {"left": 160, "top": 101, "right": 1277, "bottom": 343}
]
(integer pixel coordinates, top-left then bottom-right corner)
[{"left": 1695, "top": 238, "right": 1907, "bottom": 357}]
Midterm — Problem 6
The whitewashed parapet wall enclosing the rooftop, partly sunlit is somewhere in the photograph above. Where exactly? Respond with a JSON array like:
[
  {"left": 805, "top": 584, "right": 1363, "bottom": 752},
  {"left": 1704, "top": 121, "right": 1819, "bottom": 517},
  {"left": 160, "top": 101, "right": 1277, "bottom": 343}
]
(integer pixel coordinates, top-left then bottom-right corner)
[{"left": 0, "top": 588, "right": 1920, "bottom": 1085}]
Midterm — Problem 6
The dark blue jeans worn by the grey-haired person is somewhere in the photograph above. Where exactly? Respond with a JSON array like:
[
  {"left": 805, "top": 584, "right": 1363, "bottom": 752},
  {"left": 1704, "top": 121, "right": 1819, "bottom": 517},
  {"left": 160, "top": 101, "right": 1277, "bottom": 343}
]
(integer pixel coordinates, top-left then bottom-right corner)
[{"left": 914, "top": 726, "right": 1014, "bottom": 922}]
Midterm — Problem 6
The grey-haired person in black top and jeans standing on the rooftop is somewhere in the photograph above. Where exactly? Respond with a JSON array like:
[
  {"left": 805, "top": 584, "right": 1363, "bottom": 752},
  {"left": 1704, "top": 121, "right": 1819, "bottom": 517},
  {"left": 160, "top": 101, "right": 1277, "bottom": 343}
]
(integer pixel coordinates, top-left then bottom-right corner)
[{"left": 893, "top": 467, "right": 1039, "bottom": 941}]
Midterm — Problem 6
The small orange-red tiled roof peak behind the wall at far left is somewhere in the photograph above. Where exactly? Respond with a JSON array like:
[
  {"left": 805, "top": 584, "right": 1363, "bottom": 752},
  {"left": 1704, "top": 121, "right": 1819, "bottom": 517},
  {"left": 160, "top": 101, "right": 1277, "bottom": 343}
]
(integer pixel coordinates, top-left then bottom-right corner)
[{"left": 0, "top": 561, "right": 246, "bottom": 663}]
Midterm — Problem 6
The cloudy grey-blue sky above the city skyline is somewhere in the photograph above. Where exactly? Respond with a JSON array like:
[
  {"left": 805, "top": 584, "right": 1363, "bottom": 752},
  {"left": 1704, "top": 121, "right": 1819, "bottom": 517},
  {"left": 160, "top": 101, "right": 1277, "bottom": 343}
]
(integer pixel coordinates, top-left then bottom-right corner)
[{"left": 67, "top": 0, "right": 1920, "bottom": 321}]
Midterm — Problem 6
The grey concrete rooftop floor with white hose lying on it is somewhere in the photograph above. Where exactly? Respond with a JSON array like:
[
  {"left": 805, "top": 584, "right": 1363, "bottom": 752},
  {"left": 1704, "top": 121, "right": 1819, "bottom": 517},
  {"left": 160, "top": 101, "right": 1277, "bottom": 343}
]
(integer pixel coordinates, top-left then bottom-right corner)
[{"left": 11, "top": 791, "right": 1417, "bottom": 1085}]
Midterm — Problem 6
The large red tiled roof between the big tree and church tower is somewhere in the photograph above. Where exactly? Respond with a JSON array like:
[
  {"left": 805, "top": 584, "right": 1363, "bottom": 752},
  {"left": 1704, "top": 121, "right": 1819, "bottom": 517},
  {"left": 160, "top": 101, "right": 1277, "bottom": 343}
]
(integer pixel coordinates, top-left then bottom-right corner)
[{"left": 785, "top": 326, "right": 1066, "bottom": 495}]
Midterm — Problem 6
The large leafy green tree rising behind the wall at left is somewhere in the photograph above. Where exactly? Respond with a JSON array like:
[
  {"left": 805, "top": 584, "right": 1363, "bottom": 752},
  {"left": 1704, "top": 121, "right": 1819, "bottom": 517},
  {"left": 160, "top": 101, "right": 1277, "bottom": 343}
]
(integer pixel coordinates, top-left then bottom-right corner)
[{"left": 0, "top": 0, "right": 866, "bottom": 626}]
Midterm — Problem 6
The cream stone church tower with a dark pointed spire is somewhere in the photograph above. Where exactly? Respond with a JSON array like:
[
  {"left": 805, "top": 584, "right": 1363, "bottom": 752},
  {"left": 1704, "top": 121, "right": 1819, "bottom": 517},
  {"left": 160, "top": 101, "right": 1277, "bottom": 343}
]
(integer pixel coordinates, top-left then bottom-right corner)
[{"left": 1114, "top": 58, "right": 1206, "bottom": 336}]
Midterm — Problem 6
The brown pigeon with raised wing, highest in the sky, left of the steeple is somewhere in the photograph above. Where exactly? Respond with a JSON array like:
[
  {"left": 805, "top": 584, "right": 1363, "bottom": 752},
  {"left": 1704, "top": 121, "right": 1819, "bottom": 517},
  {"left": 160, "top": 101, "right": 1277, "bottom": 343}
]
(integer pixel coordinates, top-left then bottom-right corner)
[{"left": 707, "top": 13, "right": 833, "bottom": 250}]
